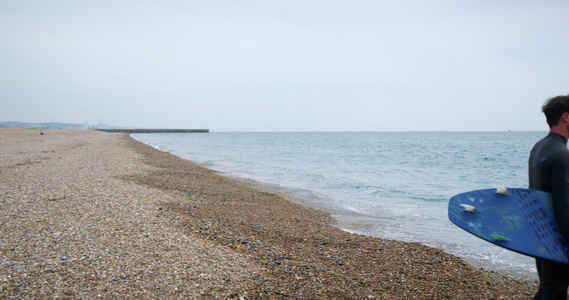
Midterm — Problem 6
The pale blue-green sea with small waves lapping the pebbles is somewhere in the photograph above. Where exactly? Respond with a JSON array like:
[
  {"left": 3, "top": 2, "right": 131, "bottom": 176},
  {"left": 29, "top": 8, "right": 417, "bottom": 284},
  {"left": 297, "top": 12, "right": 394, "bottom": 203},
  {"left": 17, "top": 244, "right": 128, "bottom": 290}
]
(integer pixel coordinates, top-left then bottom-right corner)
[{"left": 132, "top": 131, "right": 547, "bottom": 280}]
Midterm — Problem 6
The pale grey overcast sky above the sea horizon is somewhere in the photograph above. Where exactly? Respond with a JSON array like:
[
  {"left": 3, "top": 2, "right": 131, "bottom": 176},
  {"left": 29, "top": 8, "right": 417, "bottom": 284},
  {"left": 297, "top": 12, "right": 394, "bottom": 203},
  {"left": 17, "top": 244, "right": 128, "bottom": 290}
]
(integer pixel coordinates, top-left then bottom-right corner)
[{"left": 0, "top": 0, "right": 569, "bottom": 131}]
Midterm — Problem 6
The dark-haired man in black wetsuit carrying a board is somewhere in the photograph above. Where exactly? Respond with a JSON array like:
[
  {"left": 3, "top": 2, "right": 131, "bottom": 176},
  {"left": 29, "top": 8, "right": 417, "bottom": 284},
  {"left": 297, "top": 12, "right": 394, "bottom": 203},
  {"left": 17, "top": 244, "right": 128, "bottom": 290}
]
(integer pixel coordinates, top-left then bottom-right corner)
[{"left": 529, "top": 95, "right": 569, "bottom": 300}]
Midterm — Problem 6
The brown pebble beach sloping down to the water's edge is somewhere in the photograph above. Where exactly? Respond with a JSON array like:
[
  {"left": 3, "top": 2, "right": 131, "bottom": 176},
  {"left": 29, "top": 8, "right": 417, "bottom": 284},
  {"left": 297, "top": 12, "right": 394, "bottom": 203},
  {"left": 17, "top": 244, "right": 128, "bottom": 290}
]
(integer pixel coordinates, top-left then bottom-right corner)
[{"left": 0, "top": 128, "right": 537, "bottom": 299}]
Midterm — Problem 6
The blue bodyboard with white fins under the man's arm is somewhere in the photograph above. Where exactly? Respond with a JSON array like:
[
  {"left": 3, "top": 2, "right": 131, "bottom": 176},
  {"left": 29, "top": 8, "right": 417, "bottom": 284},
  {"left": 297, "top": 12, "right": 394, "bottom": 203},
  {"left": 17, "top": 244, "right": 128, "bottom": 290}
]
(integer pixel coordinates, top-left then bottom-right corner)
[{"left": 448, "top": 188, "right": 569, "bottom": 264}]
